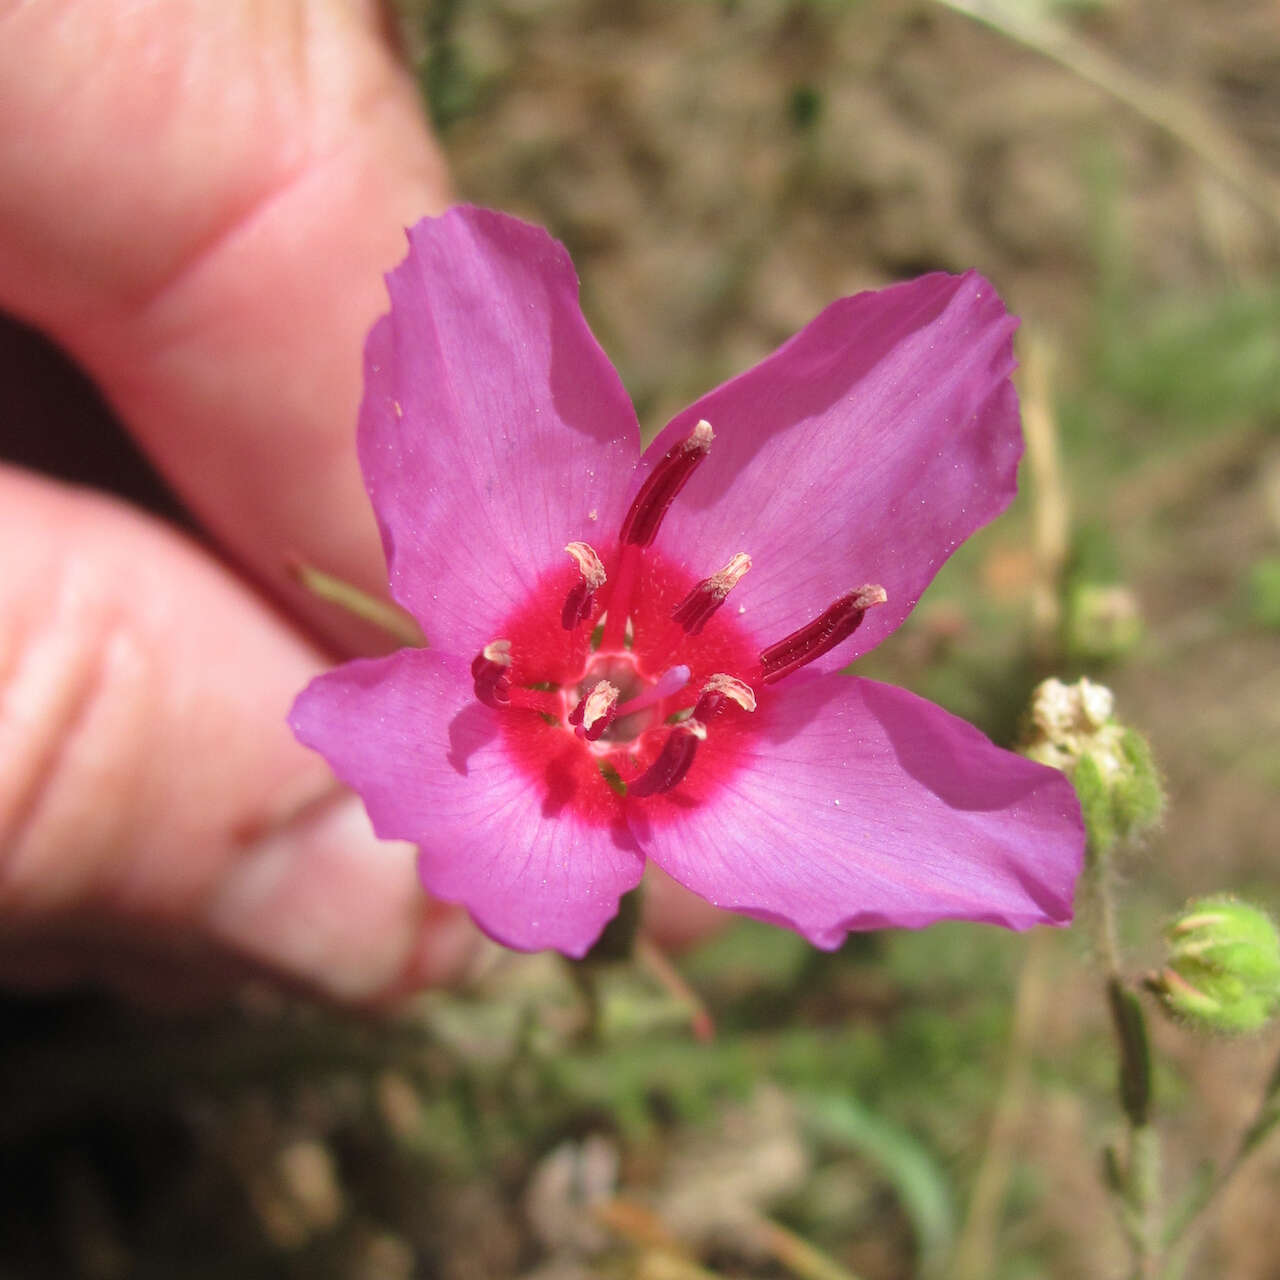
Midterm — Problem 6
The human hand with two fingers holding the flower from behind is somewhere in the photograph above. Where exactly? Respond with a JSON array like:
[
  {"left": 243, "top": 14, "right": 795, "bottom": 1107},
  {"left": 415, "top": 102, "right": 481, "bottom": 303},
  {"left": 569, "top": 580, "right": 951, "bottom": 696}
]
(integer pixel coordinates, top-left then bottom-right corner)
[{"left": 0, "top": 0, "right": 475, "bottom": 1000}]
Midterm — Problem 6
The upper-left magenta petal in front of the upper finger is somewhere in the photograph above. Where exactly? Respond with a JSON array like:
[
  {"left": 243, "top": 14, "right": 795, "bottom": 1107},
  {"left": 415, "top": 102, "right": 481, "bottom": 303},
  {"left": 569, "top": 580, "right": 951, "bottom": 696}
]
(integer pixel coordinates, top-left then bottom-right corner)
[{"left": 360, "top": 207, "right": 640, "bottom": 655}]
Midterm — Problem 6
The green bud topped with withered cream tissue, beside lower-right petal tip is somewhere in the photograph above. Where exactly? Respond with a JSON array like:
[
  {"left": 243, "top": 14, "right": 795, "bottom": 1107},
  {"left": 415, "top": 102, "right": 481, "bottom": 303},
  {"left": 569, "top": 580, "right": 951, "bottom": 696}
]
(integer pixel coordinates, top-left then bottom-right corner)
[{"left": 1023, "top": 680, "right": 1165, "bottom": 859}]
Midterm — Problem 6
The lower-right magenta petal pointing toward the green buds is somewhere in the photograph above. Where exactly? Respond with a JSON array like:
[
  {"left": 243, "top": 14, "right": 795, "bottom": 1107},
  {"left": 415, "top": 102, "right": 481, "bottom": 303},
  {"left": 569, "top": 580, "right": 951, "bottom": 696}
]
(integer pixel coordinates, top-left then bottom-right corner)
[{"left": 628, "top": 676, "right": 1084, "bottom": 947}]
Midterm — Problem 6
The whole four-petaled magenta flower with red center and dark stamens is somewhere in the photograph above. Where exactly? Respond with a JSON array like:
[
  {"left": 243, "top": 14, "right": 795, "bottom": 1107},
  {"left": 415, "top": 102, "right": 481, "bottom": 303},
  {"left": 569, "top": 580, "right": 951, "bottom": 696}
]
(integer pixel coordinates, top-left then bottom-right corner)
[{"left": 292, "top": 209, "right": 1083, "bottom": 956}]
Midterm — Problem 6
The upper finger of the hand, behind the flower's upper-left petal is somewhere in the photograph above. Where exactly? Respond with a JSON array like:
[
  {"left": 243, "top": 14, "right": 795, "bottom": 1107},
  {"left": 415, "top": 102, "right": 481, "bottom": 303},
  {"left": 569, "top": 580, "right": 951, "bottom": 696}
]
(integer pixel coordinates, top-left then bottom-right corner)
[{"left": 0, "top": 0, "right": 447, "bottom": 640}]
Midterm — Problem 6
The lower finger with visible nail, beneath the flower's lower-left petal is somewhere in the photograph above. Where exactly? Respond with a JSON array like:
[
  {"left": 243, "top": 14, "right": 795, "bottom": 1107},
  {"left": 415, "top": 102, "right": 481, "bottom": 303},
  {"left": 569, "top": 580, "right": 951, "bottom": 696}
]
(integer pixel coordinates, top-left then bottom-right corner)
[{"left": 0, "top": 470, "right": 472, "bottom": 1001}]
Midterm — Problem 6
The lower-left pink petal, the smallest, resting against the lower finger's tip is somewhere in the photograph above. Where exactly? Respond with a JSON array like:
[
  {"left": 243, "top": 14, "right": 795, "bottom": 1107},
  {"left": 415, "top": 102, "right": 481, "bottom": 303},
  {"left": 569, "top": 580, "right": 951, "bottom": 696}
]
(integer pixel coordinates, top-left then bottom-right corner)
[{"left": 289, "top": 649, "right": 644, "bottom": 956}]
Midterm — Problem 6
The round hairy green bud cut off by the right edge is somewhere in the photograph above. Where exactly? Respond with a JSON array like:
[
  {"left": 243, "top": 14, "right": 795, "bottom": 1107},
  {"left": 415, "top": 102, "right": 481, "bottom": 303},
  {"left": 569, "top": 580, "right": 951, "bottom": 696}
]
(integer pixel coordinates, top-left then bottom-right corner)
[{"left": 1148, "top": 895, "right": 1280, "bottom": 1036}]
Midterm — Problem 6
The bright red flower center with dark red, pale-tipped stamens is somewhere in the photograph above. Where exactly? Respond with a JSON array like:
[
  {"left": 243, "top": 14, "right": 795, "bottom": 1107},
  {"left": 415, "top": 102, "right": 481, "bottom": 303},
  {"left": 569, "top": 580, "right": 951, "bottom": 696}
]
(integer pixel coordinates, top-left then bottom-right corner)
[{"left": 471, "top": 422, "right": 884, "bottom": 822}]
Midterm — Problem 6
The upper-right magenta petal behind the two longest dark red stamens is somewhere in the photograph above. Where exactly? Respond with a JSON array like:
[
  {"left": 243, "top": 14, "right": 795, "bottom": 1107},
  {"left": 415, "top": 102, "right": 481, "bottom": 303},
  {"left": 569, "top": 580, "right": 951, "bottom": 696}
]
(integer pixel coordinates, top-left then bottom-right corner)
[{"left": 632, "top": 273, "right": 1021, "bottom": 671}]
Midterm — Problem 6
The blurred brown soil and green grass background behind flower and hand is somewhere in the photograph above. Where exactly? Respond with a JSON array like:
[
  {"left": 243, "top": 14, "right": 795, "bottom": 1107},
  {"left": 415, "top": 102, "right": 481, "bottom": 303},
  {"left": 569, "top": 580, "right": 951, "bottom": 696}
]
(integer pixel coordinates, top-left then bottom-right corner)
[{"left": 0, "top": 0, "right": 1280, "bottom": 1280}]
